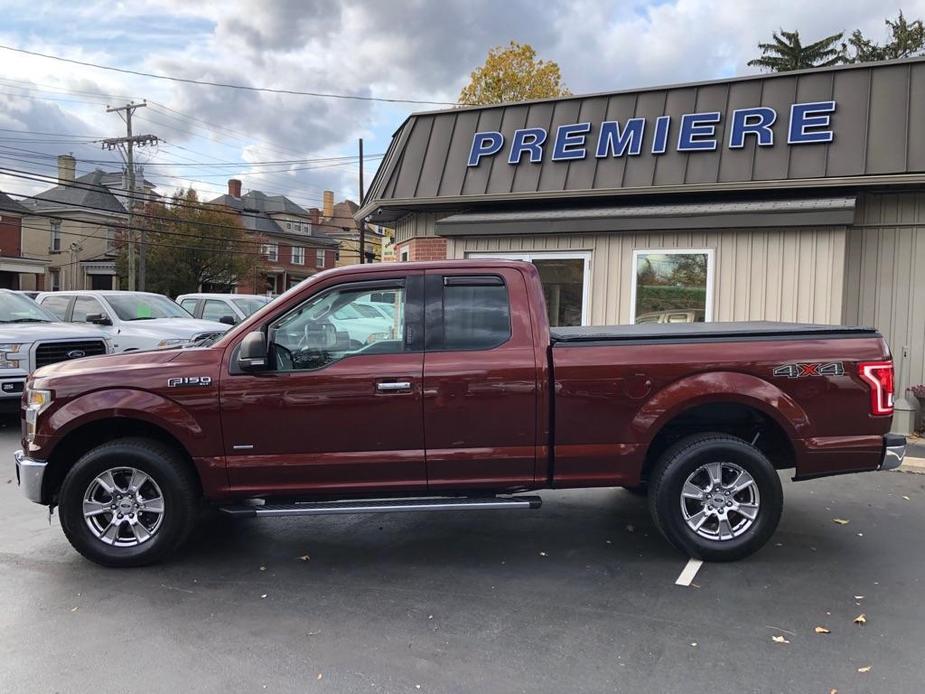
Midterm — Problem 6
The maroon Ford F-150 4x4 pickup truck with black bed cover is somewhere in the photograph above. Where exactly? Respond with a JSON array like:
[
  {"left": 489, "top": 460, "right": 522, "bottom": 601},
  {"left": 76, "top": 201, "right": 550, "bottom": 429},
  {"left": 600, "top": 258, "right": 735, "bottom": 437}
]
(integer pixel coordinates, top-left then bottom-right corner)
[{"left": 16, "top": 261, "right": 905, "bottom": 566}]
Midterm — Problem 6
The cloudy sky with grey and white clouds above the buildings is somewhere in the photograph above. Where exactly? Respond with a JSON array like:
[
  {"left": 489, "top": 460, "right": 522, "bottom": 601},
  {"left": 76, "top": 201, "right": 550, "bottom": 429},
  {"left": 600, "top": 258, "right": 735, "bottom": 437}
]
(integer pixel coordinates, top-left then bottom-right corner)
[{"left": 0, "top": 0, "right": 925, "bottom": 206}]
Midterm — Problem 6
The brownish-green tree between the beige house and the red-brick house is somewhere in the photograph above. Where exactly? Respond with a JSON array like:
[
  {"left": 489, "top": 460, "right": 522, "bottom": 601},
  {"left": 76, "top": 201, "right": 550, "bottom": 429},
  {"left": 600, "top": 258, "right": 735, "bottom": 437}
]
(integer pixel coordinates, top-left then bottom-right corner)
[{"left": 118, "top": 188, "right": 262, "bottom": 296}]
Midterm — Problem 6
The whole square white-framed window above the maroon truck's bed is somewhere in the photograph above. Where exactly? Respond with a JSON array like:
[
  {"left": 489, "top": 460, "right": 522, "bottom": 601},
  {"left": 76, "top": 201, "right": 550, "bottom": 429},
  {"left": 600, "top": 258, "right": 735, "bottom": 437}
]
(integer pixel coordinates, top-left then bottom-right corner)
[{"left": 630, "top": 249, "right": 713, "bottom": 323}]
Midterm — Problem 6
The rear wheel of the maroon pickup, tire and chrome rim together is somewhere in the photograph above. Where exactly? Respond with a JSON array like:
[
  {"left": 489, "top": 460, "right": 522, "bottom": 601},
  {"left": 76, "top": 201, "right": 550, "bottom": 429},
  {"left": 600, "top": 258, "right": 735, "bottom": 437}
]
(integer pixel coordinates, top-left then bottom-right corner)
[{"left": 649, "top": 434, "right": 783, "bottom": 561}]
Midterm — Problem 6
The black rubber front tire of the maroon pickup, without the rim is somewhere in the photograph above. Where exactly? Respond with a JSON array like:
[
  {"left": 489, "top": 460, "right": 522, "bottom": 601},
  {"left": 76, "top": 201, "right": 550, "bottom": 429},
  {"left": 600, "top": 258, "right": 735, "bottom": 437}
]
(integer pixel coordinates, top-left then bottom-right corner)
[{"left": 58, "top": 438, "right": 200, "bottom": 567}]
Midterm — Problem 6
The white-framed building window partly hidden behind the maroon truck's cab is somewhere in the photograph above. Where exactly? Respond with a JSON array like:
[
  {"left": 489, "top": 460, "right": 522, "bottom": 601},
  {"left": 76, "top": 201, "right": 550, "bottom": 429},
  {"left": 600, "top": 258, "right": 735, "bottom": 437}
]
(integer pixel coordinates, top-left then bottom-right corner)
[{"left": 466, "top": 248, "right": 591, "bottom": 327}]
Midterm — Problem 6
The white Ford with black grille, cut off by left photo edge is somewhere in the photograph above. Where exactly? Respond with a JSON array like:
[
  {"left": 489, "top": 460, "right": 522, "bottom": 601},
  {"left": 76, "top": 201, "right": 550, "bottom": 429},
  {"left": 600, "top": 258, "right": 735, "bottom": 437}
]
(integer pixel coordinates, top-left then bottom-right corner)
[{"left": 0, "top": 289, "right": 112, "bottom": 411}]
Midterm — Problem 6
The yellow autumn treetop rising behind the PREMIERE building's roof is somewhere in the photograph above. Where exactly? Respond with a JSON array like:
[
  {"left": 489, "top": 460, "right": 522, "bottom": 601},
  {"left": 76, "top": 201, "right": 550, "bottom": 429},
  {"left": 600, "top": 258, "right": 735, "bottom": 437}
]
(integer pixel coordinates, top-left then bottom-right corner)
[{"left": 459, "top": 41, "right": 571, "bottom": 105}]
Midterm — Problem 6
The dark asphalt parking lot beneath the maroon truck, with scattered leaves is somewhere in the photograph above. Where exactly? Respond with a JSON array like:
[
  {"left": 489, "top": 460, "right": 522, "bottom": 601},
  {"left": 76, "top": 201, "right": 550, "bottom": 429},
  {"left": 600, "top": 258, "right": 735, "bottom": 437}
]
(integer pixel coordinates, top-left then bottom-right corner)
[{"left": 0, "top": 418, "right": 925, "bottom": 694}]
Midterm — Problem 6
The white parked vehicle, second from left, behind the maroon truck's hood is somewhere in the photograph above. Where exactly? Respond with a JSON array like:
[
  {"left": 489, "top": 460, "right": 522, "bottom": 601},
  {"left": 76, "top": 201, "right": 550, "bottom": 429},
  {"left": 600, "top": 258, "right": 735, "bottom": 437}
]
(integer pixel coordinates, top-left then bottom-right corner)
[{"left": 36, "top": 291, "right": 228, "bottom": 352}]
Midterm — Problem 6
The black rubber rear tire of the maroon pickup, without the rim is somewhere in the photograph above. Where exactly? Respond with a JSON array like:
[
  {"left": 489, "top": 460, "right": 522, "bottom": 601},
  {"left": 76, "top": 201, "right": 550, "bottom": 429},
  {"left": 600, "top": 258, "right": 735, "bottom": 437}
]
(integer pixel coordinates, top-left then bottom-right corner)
[{"left": 649, "top": 433, "right": 783, "bottom": 561}]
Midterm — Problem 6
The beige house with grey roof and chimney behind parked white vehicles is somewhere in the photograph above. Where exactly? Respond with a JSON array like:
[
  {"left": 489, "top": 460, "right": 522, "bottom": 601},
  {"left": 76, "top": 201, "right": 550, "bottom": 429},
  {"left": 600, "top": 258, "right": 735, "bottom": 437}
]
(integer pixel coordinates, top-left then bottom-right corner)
[{"left": 23, "top": 154, "right": 153, "bottom": 290}]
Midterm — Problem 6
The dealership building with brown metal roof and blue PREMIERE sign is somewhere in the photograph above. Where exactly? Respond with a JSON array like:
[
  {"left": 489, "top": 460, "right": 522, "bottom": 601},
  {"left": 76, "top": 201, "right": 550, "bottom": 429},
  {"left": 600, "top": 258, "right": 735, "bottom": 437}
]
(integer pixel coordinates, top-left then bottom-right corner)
[{"left": 357, "top": 59, "right": 925, "bottom": 430}]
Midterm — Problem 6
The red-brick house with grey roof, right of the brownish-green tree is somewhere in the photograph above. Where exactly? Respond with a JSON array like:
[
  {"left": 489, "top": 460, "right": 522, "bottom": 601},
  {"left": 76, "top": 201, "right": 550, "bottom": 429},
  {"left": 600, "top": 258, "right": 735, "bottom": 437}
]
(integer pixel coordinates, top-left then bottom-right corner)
[{"left": 210, "top": 178, "right": 339, "bottom": 294}]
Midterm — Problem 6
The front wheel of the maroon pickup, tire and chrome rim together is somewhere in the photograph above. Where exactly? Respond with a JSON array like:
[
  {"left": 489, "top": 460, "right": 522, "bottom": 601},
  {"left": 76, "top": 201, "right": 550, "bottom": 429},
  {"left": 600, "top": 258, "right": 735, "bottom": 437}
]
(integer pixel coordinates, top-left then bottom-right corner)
[{"left": 58, "top": 438, "right": 199, "bottom": 567}]
